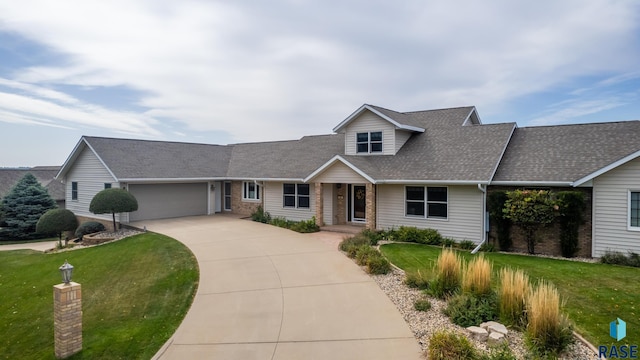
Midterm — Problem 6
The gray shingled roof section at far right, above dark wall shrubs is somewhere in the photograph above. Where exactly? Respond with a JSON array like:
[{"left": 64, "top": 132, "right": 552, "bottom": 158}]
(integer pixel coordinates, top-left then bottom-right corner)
[{"left": 494, "top": 121, "right": 640, "bottom": 182}]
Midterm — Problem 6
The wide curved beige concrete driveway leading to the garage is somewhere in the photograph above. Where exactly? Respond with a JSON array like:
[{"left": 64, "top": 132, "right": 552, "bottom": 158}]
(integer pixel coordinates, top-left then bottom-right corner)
[{"left": 135, "top": 215, "right": 420, "bottom": 360}]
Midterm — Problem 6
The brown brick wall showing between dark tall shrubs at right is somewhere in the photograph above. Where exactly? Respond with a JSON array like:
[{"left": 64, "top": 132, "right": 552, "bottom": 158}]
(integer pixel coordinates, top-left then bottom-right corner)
[{"left": 488, "top": 186, "right": 593, "bottom": 258}]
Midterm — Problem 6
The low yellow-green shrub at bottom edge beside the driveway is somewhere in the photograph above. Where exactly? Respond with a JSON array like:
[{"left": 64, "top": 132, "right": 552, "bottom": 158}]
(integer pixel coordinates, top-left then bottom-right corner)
[{"left": 425, "top": 331, "right": 478, "bottom": 360}]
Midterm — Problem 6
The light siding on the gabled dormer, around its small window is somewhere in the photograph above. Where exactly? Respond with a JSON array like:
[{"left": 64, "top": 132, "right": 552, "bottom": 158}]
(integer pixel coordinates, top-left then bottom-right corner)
[{"left": 344, "top": 111, "right": 396, "bottom": 156}]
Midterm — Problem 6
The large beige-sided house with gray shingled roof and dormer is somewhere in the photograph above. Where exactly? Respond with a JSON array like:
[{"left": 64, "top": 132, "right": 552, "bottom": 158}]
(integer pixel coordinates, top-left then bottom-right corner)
[{"left": 57, "top": 104, "right": 640, "bottom": 256}]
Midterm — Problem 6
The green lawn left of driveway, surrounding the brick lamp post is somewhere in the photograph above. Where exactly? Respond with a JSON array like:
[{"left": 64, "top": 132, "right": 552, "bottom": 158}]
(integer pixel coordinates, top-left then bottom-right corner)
[{"left": 0, "top": 233, "right": 198, "bottom": 359}]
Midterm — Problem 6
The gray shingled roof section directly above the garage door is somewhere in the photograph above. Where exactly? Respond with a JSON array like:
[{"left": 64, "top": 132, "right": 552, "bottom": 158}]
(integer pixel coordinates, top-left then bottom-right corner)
[{"left": 84, "top": 136, "right": 232, "bottom": 179}]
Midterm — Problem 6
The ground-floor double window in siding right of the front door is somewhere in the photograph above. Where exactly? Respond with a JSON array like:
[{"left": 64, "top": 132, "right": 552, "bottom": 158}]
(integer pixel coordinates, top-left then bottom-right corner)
[{"left": 405, "top": 186, "right": 449, "bottom": 219}]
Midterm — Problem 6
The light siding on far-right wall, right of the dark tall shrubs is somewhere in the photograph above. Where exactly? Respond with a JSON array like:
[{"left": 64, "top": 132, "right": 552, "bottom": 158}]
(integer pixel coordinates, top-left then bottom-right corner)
[{"left": 593, "top": 159, "right": 640, "bottom": 257}]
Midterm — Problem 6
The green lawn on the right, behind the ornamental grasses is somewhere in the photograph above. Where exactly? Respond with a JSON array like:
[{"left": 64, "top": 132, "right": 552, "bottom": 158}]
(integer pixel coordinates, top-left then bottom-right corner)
[{"left": 380, "top": 244, "right": 640, "bottom": 347}]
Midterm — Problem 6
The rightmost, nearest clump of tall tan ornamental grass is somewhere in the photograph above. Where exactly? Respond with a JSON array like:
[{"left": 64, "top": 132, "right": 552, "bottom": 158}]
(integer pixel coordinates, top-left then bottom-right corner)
[{"left": 525, "top": 282, "right": 573, "bottom": 357}]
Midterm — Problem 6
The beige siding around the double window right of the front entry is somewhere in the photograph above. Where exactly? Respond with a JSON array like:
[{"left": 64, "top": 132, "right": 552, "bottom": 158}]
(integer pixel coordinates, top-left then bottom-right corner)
[{"left": 377, "top": 185, "right": 483, "bottom": 243}]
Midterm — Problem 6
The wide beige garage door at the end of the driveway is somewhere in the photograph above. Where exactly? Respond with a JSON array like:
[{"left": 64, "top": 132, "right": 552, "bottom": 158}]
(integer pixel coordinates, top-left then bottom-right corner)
[{"left": 129, "top": 183, "right": 208, "bottom": 221}]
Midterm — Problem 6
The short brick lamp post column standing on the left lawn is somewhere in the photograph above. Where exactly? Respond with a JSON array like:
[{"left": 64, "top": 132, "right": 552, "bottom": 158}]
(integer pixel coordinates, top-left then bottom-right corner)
[{"left": 53, "top": 281, "right": 82, "bottom": 359}]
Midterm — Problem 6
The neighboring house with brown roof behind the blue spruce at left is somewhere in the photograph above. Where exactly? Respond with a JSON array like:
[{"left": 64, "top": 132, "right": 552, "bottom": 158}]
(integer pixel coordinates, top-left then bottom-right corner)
[{"left": 0, "top": 166, "right": 65, "bottom": 209}]
